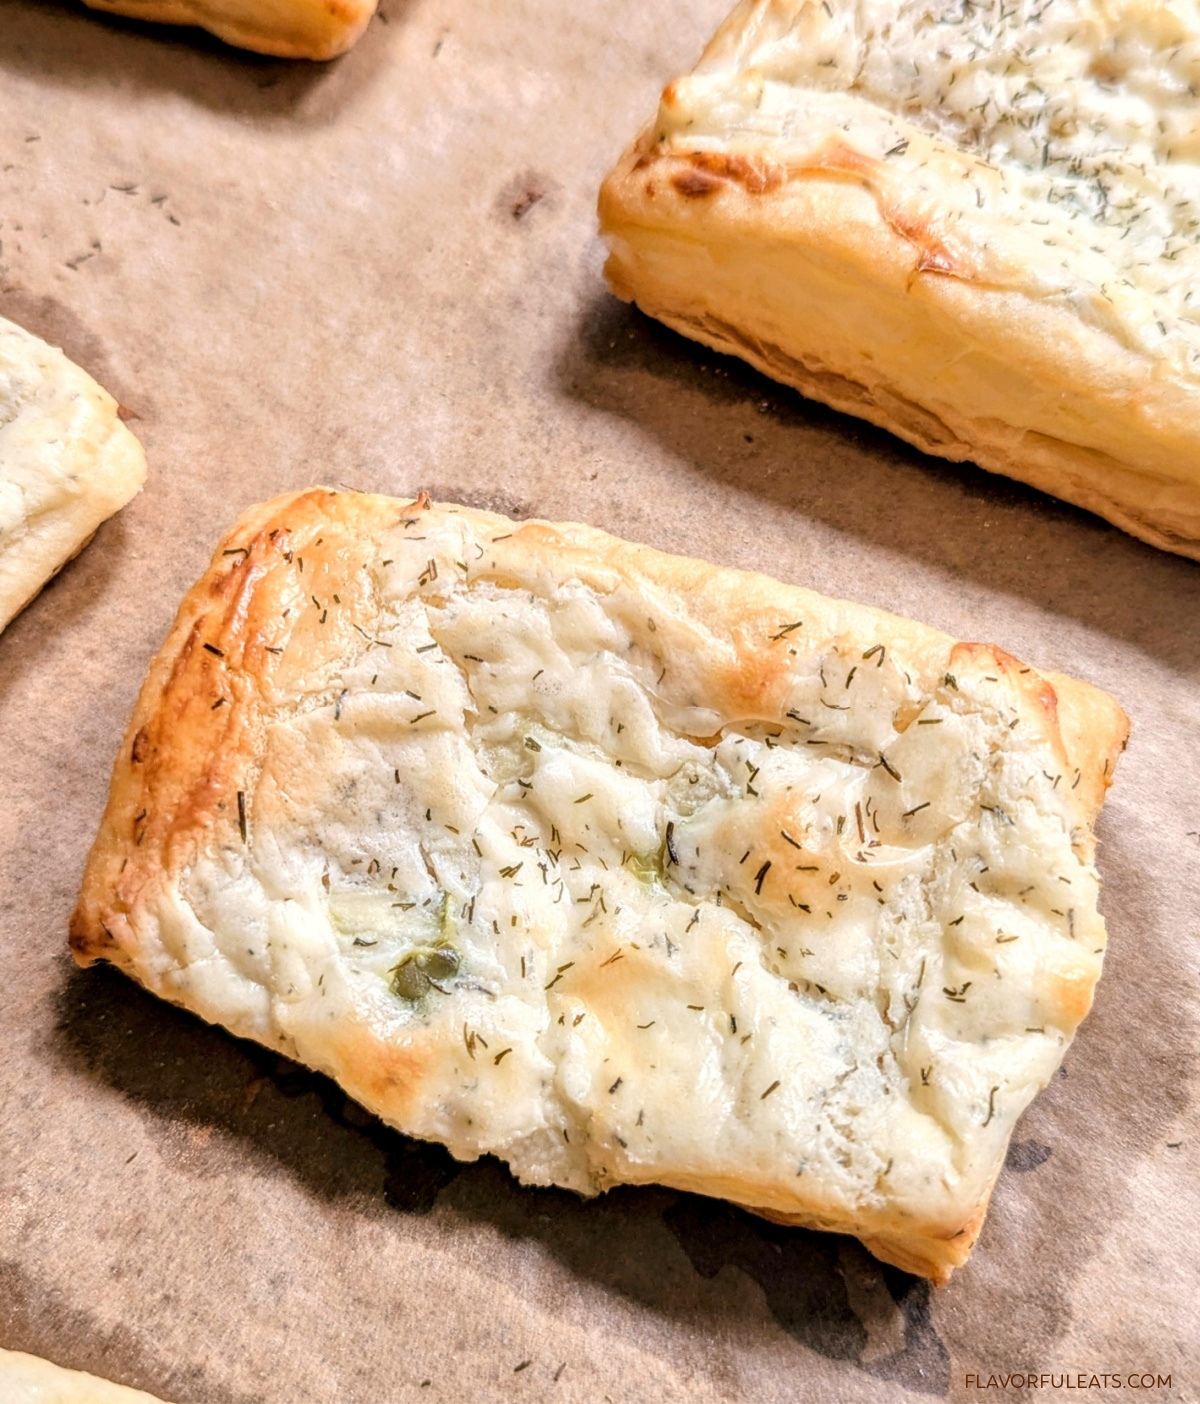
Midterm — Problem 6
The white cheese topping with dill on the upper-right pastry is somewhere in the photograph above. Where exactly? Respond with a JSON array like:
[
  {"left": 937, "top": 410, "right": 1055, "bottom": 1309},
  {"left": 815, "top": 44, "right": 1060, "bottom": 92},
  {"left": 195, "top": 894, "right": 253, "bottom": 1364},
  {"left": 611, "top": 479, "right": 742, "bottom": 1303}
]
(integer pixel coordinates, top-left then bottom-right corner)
[{"left": 657, "top": 0, "right": 1200, "bottom": 356}]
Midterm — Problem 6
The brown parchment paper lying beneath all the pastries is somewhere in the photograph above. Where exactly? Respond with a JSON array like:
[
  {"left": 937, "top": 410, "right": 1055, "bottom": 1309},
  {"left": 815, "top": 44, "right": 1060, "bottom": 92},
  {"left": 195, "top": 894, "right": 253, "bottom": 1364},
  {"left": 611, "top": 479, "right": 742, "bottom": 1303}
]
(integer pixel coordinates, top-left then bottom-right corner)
[{"left": 0, "top": 0, "right": 1200, "bottom": 1404}]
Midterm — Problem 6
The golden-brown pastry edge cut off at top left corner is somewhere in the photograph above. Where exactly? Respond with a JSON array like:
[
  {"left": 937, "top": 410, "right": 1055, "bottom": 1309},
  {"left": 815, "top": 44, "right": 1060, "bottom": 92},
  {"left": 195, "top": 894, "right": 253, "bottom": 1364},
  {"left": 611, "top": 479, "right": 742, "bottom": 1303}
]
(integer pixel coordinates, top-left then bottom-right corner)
[{"left": 84, "top": 0, "right": 379, "bottom": 59}]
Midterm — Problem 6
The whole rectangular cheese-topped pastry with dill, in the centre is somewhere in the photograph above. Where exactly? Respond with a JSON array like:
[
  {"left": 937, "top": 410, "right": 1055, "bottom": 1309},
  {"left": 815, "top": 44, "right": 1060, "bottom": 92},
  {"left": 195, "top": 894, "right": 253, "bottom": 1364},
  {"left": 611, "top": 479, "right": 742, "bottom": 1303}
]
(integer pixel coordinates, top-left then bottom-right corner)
[{"left": 70, "top": 490, "right": 1127, "bottom": 1282}]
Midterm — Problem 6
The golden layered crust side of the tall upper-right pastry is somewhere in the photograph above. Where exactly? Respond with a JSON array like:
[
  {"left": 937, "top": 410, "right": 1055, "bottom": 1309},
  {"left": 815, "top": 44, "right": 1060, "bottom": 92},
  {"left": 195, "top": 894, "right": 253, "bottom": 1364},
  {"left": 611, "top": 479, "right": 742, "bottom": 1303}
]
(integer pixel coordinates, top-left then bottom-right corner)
[{"left": 599, "top": 72, "right": 1200, "bottom": 559}]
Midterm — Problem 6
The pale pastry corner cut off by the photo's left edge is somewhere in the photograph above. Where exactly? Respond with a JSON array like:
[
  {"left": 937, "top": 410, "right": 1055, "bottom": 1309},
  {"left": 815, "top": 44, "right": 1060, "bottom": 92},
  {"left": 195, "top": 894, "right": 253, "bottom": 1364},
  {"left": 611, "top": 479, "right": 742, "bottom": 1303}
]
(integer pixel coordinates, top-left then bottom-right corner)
[{"left": 0, "top": 317, "right": 146, "bottom": 629}]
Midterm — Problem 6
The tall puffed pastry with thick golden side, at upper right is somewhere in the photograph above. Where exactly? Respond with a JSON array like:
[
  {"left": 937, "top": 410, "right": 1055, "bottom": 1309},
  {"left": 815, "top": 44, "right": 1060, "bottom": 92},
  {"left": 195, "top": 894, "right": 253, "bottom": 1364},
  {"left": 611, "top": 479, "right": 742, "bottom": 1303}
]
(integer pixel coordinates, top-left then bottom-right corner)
[{"left": 599, "top": 0, "right": 1200, "bottom": 559}]
